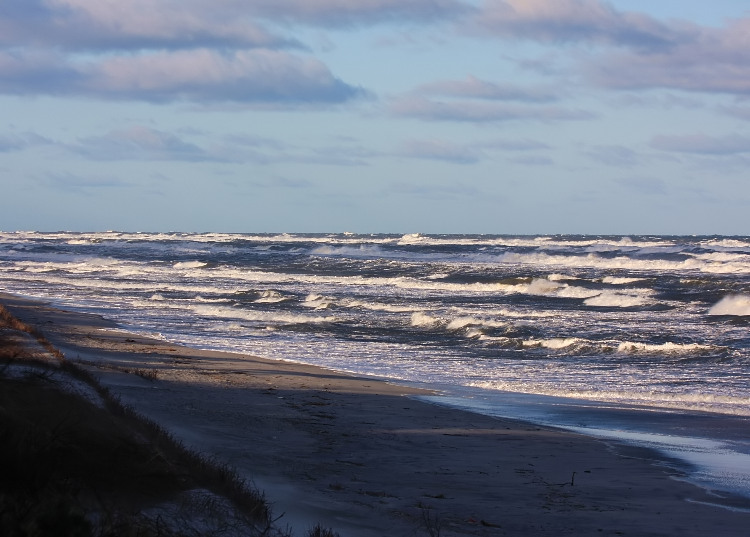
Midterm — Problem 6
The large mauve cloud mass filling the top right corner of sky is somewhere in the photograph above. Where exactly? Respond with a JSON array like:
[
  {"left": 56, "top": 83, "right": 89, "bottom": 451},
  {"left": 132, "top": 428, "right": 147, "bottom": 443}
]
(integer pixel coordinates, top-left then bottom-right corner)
[{"left": 462, "top": 0, "right": 750, "bottom": 95}]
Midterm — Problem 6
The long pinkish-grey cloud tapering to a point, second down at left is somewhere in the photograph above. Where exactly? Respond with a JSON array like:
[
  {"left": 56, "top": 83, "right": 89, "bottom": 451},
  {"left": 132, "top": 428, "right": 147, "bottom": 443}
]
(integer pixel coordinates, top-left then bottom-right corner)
[{"left": 0, "top": 49, "right": 364, "bottom": 104}]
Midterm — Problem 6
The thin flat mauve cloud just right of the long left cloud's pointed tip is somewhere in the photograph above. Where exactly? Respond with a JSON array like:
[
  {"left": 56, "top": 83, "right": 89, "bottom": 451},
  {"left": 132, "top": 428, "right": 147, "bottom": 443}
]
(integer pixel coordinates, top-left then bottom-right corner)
[{"left": 389, "top": 96, "right": 594, "bottom": 123}]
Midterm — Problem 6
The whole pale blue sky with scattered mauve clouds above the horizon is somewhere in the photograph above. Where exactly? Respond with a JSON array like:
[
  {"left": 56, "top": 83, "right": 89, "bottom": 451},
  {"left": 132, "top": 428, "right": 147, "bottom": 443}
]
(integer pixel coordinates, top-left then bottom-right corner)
[{"left": 0, "top": 0, "right": 750, "bottom": 235}]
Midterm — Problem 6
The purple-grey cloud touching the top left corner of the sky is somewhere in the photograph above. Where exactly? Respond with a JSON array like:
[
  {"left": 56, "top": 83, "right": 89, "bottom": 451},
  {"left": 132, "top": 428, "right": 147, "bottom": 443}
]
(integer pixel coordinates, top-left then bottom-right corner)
[{"left": 0, "top": 0, "right": 298, "bottom": 50}]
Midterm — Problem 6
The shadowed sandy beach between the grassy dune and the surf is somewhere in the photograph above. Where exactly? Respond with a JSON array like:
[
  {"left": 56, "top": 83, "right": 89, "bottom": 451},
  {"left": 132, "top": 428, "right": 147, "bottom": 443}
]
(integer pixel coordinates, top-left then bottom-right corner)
[{"left": 0, "top": 295, "right": 750, "bottom": 537}]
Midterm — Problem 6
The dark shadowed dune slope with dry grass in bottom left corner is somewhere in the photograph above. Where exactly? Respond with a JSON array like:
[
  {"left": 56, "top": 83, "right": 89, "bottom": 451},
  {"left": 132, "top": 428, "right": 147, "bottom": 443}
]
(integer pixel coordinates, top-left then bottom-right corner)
[{"left": 0, "top": 306, "right": 300, "bottom": 537}]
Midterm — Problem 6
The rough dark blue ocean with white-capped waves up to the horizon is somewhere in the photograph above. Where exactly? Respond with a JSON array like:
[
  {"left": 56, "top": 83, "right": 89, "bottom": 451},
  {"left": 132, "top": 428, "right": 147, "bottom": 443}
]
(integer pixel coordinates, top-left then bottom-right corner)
[{"left": 0, "top": 232, "right": 750, "bottom": 496}]
